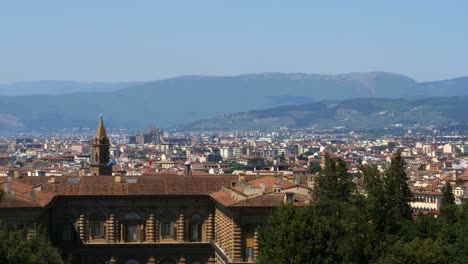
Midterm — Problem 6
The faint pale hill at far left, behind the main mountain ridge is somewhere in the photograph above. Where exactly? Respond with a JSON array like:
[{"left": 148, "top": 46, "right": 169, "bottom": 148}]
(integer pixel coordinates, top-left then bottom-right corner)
[{"left": 0, "top": 81, "right": 143, "bottom": 96}]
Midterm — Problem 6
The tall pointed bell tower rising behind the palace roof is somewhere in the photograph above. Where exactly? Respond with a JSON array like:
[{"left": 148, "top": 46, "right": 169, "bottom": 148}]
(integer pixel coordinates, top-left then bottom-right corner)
[{"left": 91, "top": 114, "right": 112, "bottom": 176}]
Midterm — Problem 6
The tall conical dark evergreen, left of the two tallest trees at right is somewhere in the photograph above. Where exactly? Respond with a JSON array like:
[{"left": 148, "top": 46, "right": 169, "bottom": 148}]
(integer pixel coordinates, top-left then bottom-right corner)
[{"left": 312, "top": 157, "right": 367, "bottom": 263}]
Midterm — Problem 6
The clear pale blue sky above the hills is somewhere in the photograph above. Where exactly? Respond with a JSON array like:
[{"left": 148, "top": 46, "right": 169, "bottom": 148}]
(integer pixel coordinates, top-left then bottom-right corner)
[{"left": 0, "top": 0, "right": 468, "bottom": 83}]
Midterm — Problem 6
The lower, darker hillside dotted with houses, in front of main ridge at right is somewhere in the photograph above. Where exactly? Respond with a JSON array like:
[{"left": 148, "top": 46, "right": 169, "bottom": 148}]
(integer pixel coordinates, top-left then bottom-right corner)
[{"left": 180, "top": 96, "right": 468, "bottom": 130}]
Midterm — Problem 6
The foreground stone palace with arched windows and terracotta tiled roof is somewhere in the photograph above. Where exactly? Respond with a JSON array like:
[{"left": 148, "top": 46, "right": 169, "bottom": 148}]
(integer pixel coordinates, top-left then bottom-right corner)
[{"left": 0, "top": 175, "right": 305, "bottom": 264}]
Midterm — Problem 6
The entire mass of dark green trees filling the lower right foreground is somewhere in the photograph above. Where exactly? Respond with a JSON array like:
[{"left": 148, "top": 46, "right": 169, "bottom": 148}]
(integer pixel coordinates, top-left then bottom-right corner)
[{"left": 258, "top": 152, "right": 468, "bottom": 264}]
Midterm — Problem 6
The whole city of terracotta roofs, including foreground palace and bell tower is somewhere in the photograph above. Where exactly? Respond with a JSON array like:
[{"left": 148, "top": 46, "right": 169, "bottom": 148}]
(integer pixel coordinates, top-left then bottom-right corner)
[{"left": 0, "top": 115, "right": 468, "bottom": 263}]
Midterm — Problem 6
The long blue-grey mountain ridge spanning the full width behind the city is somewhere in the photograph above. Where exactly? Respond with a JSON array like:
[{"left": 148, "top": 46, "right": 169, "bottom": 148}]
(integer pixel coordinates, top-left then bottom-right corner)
[{"left": 0, "top": 72, "right": 468, "bottom": 132}]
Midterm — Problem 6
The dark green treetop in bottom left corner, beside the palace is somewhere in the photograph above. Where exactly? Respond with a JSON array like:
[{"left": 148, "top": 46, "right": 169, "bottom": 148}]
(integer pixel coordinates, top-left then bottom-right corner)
[{"left": 0, "top": 223, "right": 63, "bottom": 264}]
